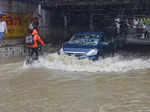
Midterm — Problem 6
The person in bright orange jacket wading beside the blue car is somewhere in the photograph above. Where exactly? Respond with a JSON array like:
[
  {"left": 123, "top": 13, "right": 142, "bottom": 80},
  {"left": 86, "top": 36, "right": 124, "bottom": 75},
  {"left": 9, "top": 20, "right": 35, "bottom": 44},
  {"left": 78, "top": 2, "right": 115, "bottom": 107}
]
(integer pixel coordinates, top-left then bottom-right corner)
[{"left": 27, "top": 29, "right": 45, "bottom": 60}]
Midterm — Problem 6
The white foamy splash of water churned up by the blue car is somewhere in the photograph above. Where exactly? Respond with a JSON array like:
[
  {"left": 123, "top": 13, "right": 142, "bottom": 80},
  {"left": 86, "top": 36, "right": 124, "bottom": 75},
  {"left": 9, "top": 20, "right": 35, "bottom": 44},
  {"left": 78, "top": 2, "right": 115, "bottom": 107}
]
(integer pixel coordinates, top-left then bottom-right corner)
[{"left": 33, "top": 53, "right": 150, "bottom": 72}]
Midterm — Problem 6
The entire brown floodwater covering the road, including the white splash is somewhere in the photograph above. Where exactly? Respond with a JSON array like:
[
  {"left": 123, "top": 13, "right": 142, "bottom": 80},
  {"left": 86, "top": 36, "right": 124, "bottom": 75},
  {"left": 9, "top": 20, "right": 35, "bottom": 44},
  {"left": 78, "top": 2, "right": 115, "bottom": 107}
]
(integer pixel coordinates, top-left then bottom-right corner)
[{"left": 0, "top": 45, "right": 150, "bottom": 112}]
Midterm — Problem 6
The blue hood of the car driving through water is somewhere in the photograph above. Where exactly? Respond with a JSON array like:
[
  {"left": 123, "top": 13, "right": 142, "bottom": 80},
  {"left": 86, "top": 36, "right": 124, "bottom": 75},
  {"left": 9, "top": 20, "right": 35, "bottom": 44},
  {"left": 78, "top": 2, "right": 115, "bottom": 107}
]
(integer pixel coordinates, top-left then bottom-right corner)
[{"left": 63, "top": 43, "right": 97, "bottom": 53}]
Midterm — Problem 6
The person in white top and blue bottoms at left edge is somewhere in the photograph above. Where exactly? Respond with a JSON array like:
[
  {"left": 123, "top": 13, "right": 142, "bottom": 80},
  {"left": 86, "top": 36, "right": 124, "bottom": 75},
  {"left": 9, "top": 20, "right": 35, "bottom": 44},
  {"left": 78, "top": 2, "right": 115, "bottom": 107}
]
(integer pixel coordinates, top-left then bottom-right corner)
[{"left": 0, "top": 15, "right": 8, "bottom": 47}]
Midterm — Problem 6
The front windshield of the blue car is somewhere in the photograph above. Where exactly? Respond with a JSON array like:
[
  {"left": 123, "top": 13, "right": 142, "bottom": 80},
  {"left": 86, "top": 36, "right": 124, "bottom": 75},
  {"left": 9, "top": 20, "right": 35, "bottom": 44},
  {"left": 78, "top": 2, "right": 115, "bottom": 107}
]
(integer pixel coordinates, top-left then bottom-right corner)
[{"left": 69, "top": 34, "right": 100, "bottom": 45}]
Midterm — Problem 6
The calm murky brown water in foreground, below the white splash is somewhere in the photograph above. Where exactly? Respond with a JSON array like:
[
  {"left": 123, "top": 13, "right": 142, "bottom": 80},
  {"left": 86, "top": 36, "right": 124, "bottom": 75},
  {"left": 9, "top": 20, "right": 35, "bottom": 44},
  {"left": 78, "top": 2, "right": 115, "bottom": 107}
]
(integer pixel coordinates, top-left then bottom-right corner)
[{"left": 0, "top": 58, "right": 150, "bottom": 112}]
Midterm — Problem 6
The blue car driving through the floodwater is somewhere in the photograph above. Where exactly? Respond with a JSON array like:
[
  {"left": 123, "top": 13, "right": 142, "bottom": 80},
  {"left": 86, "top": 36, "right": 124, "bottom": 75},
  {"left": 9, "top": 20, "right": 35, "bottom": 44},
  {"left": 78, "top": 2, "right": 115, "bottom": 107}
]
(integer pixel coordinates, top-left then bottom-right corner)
[{"left": 58, "top": 32, "right": 117, "bottom": 60}]
